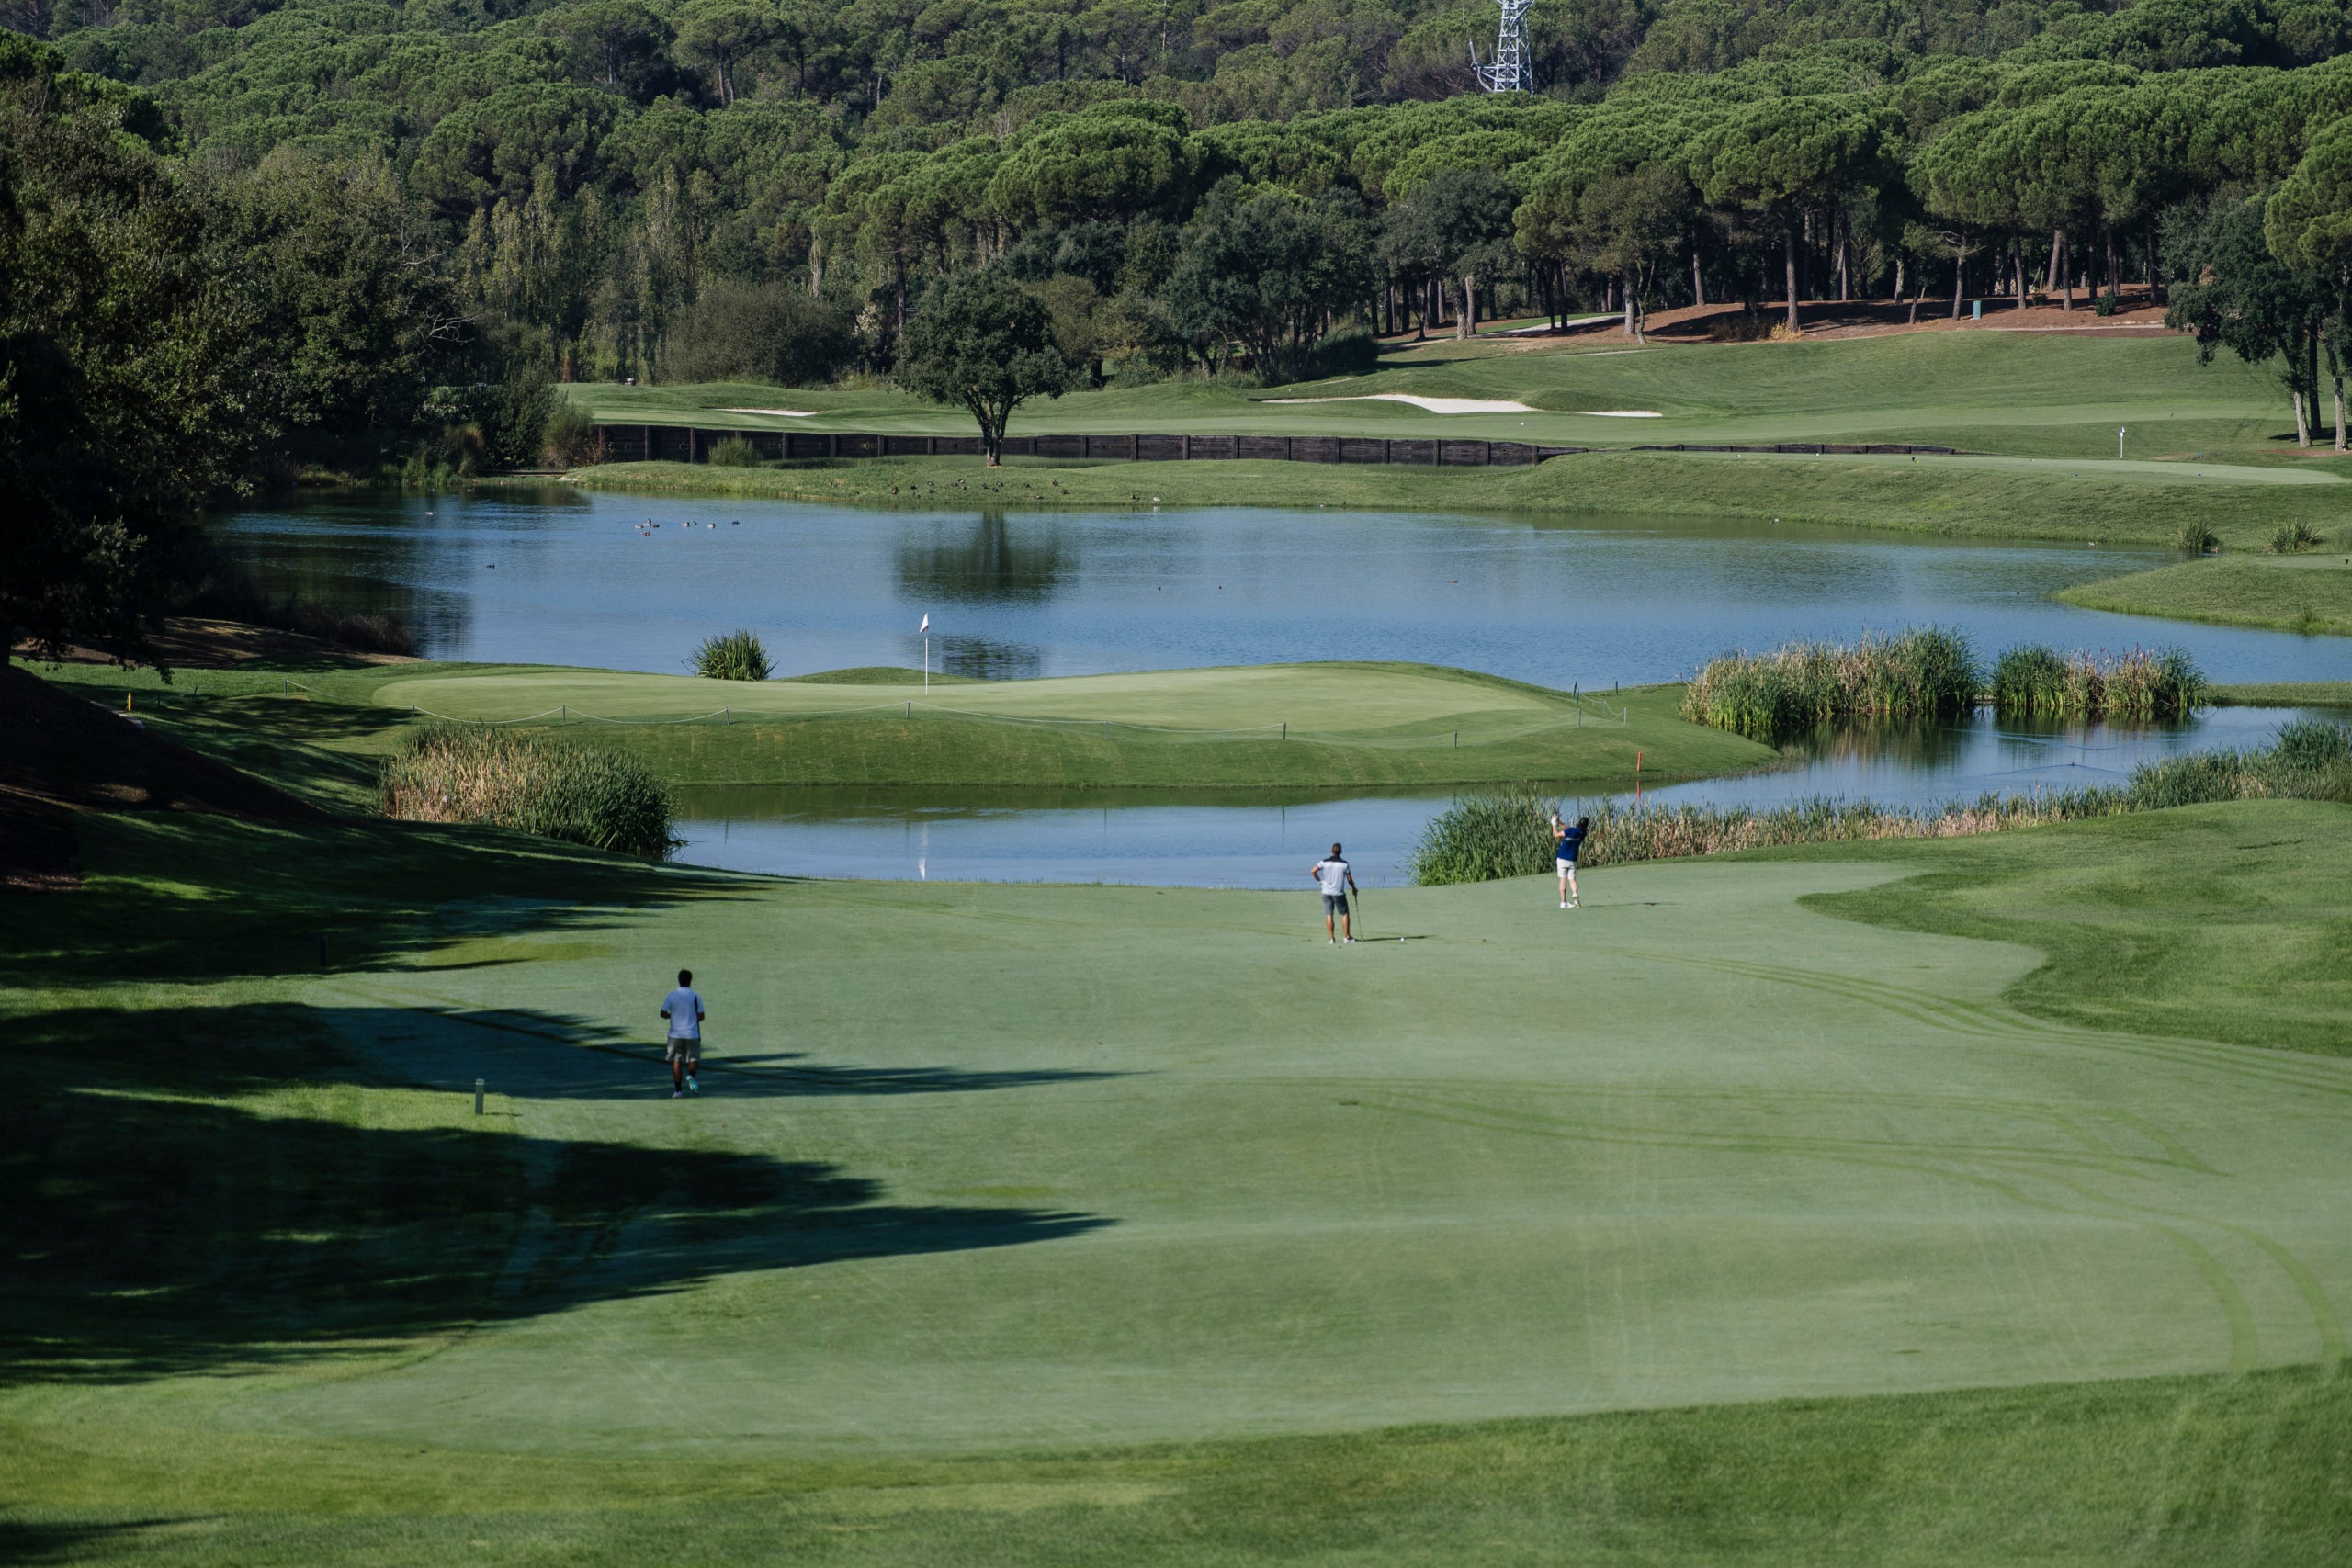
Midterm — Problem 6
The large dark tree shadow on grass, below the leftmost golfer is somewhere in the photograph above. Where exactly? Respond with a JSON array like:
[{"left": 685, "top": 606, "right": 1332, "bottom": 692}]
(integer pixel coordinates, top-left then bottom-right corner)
[{"left": 0, "top": 1006, "right": 1108, "bottom": 1382}]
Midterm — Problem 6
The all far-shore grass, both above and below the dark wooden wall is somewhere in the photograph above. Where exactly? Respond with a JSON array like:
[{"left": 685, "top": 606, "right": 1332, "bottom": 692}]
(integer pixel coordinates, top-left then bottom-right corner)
[{"left": 550, "top": 332, "right": 2352, "bottom": 550}]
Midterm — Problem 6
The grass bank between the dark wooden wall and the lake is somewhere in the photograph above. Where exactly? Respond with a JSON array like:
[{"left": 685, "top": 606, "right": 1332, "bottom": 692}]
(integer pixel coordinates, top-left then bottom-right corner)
[{"left": 571, "top": 451, "right": 2352, "bottom": 550}]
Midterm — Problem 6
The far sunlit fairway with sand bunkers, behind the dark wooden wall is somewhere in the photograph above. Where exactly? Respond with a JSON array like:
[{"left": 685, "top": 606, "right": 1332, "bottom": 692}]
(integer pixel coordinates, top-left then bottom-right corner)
[{"left": 567, "top": 332, "right": 2334, "bottom": 463}]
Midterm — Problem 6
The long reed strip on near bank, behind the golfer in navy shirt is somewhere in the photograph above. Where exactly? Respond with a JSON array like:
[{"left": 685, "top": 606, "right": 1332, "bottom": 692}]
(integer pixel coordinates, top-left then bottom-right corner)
[{"left": 1408, "top": 719, "right": 2352, "bottom": 886}]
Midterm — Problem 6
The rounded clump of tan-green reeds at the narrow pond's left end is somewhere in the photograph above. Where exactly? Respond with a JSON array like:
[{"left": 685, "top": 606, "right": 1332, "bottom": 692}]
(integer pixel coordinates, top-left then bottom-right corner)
[{"left": 381, "top": 724, "right": 677, "bottom": 858}]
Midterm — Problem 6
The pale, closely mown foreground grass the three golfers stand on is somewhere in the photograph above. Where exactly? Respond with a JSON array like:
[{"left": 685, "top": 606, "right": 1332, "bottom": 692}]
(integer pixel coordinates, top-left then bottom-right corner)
[{"left": 17, "top": 807, "right": 2352, "bottom": 1455}]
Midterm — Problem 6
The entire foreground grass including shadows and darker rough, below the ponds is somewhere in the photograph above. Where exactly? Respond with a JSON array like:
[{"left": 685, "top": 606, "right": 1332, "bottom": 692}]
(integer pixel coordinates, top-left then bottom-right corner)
[{"left": 0, "top": 802, "right": 2352, "bottom": 1563}]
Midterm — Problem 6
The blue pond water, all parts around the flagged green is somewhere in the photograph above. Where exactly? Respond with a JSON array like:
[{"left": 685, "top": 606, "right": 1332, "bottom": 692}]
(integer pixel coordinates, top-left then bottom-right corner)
[{"left": 217, "top": 489, "right": 2352, "bottom": 886}]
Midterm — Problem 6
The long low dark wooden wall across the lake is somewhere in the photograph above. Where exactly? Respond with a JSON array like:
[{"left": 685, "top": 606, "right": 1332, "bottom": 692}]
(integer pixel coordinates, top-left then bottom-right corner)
[{"left": 595, "top": 425, "right": 1589, "bottom": 468}]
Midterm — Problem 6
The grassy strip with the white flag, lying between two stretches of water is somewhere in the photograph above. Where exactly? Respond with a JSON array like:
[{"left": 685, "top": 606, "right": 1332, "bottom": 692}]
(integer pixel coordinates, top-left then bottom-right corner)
[{"left": 28, "top": 663, "right": 1778, "bottom": 789}]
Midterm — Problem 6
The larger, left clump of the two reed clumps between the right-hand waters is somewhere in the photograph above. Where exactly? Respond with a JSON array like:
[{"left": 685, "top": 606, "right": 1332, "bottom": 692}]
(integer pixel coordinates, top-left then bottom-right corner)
[{"left": 1681, "top": 626, "right": 1978, "bottom": 740}]
